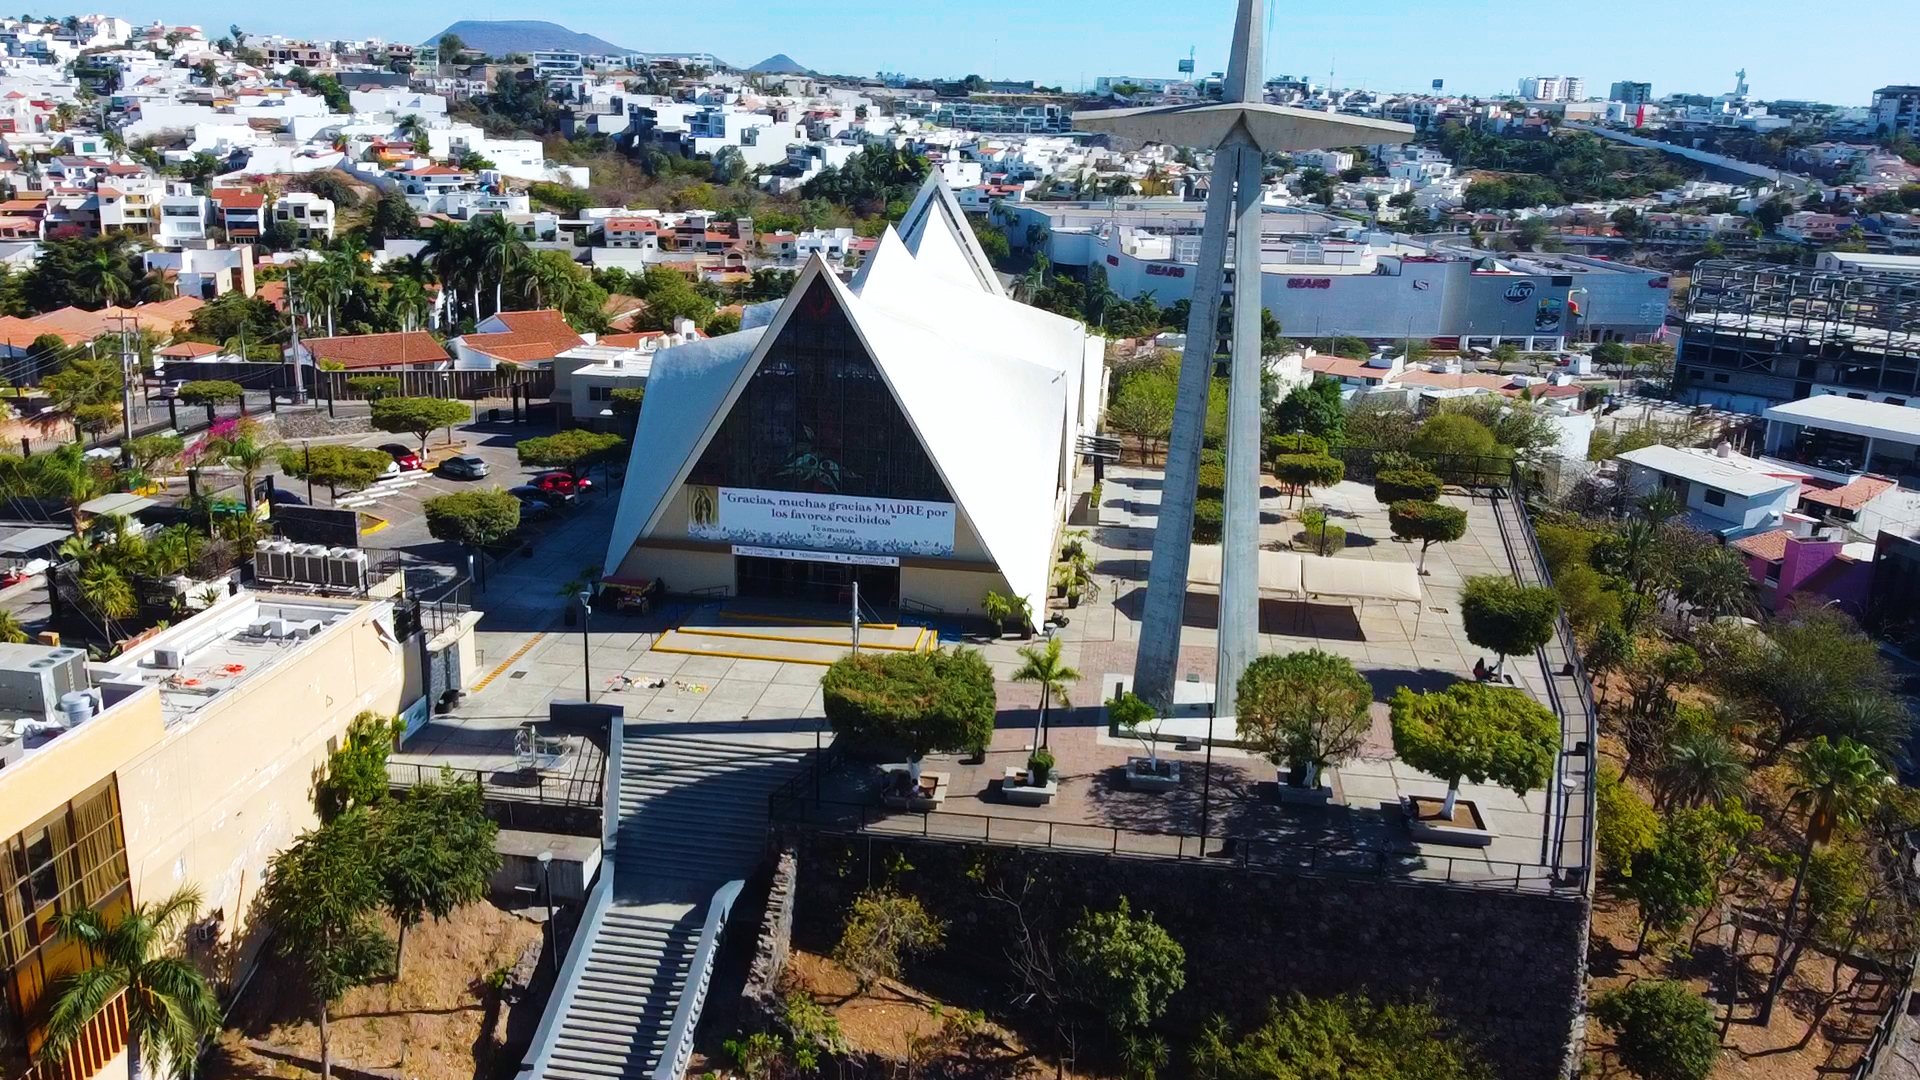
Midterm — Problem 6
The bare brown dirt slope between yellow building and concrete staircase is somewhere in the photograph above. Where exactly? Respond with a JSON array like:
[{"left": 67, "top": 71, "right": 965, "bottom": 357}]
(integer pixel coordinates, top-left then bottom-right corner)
[{"left": 207, "top": 903, "right": 541, "bottom": 1080}]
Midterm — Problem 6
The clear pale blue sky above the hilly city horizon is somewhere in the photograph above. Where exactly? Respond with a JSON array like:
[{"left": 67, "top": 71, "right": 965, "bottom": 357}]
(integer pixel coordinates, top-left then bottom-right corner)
[{"left": 121, "top": 0, "right": 1920, "bottom": 106}]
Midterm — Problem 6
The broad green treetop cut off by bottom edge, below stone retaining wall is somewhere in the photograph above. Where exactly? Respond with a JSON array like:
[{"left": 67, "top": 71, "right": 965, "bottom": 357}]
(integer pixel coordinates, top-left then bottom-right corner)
[{"left": 1192, "top": 994, "right": 1494, "bottom": 1080}]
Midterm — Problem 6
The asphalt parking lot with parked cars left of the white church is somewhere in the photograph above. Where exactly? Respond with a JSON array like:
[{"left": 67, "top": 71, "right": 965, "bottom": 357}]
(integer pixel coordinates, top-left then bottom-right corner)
[{"left": 261, "top": 423, "right": 618, "bottom": 563}]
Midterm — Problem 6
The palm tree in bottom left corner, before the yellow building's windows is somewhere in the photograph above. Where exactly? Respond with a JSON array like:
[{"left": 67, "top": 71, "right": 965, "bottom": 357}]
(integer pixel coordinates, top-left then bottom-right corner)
[{"left": 40, "top": 886, "right": 221, "bottom": 1080}]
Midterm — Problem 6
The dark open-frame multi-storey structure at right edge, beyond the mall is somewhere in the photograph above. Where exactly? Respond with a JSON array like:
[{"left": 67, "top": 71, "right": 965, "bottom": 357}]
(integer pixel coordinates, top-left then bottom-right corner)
[{"left": 1678, "top": 261, "right": 1920, "bottom": 398}]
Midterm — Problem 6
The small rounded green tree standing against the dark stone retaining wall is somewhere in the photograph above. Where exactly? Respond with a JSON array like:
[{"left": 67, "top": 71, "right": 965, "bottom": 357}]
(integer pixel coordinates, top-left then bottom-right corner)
[{"left": 1066, "top": 896, "right": 1187, "bottom": 1032}]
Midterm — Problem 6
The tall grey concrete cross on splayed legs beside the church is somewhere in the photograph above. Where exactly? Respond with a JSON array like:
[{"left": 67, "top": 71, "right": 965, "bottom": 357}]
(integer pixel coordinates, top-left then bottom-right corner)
[{"left": 1073, "top": 0, "right": 1413, "bottom": 713}]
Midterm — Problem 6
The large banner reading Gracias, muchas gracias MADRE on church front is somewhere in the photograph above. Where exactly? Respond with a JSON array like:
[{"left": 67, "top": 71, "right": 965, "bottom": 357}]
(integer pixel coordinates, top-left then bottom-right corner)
[{"left": 687, "top": 484, "right": 954, "bottom": 555}]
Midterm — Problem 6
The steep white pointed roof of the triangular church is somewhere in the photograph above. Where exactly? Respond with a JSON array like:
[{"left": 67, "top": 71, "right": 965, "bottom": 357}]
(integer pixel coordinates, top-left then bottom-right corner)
[{"left": 605, "top": 173, "right": 1102, "bottom": 611}]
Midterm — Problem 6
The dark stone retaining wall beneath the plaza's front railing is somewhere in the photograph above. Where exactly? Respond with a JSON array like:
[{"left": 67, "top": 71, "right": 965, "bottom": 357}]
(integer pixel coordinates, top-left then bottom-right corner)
[{"left": 789, "top": 830, "right": 1588, "bottom": 1080}]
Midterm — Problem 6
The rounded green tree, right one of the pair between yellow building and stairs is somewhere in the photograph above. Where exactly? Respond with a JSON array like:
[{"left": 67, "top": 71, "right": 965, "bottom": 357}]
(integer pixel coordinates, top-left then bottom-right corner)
[{"left": 374, "top": 776, "right": 499, "bottom": 976}]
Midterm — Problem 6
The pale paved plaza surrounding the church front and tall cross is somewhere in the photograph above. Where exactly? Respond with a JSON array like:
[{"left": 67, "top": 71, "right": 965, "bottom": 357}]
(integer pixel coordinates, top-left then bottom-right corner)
[{"left": 397, "top": 461, "right": 1546, "bottom": 880}]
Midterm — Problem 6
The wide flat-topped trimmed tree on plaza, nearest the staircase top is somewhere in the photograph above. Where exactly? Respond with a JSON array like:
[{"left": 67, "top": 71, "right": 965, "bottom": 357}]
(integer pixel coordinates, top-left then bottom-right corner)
[{"left": 820, "top": 648, "right": 995, "bottom": 757}]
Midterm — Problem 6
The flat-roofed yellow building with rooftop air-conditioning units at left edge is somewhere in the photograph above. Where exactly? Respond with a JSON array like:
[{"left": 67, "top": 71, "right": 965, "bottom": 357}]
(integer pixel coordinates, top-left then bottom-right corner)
[{"left": 0, "top": 592, "right": 409, "bottom": 1080}]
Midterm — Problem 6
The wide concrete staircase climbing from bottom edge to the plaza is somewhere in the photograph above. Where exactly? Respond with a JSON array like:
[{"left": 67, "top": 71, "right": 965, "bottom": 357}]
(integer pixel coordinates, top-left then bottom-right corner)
[{"left": 530, "top": 734, "right": 806, "bottom": 1080}]
